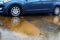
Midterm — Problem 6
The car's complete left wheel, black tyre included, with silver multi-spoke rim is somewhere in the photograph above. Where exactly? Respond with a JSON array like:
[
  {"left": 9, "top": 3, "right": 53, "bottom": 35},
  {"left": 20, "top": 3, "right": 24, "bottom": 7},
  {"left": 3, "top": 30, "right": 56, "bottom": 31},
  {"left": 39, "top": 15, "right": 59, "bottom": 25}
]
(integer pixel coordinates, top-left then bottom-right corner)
[{"left": 10, "top": 5, "right": 21, "bottom": 17}]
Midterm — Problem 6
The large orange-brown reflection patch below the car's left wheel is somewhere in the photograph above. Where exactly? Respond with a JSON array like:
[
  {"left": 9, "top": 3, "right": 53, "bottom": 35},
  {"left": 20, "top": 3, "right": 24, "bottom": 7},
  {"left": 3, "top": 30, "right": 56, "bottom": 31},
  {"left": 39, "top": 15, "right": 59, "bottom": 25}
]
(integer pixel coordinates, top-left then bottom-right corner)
[{"left": 5, "top": 17, "right": 43, "bottom": 35}]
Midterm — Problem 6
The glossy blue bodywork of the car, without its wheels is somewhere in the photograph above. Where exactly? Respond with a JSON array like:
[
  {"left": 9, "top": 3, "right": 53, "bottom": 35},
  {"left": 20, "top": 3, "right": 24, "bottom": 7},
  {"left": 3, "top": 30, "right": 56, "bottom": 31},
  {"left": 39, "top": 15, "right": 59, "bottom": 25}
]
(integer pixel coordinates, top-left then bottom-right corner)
[{"left": 0, "top": 0, "right": 60, "bottom": 14}]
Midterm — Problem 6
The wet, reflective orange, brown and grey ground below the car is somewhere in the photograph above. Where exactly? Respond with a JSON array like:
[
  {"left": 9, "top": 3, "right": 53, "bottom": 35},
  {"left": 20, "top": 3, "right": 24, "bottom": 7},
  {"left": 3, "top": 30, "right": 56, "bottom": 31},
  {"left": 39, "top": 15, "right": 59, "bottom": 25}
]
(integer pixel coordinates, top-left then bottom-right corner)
[{"left": 0, "top": 16, "right": 60, "bottom": 40}]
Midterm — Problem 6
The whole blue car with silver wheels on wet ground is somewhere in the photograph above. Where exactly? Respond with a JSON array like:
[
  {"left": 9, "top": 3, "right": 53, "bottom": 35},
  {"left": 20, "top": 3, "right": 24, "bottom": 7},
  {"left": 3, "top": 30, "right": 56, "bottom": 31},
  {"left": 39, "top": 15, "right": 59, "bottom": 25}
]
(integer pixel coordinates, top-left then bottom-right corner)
[{"left": 0, "top": 0, "right": 60, "bottom": 17}]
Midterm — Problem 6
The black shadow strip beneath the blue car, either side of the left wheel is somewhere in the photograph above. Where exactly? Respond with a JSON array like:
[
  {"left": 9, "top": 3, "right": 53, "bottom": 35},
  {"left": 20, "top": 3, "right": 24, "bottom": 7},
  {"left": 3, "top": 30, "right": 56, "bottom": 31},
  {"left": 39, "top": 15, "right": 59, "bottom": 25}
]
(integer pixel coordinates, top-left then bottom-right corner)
[{"left": 0, "top": 13, "right": 52, "bottom": 17}]
